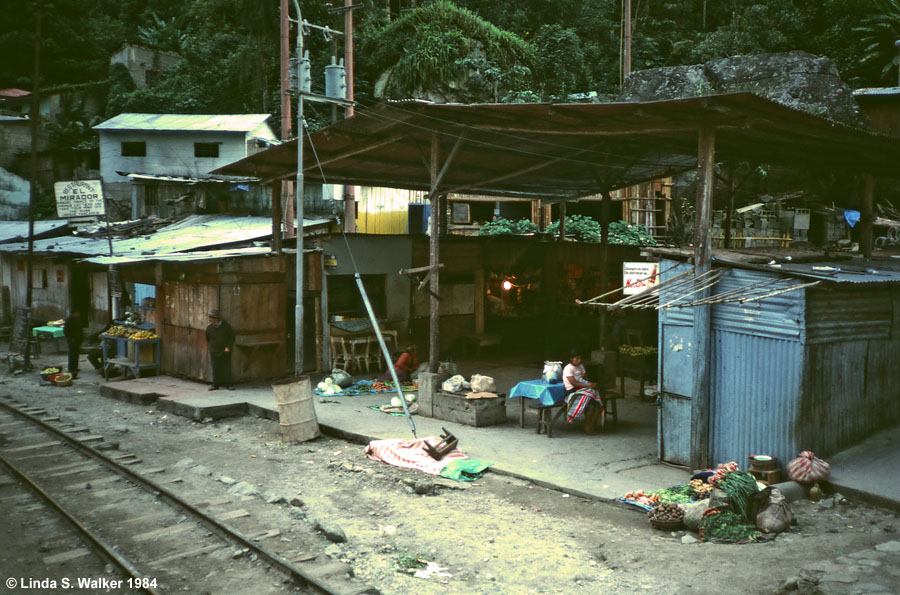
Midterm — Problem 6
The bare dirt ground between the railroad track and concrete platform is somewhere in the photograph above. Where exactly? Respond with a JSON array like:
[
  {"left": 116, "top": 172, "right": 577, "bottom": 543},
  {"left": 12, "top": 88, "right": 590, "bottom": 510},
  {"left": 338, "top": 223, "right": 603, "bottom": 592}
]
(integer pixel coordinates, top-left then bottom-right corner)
[{"left": 0, "top": 371, "right": 900, "bottom": 594}]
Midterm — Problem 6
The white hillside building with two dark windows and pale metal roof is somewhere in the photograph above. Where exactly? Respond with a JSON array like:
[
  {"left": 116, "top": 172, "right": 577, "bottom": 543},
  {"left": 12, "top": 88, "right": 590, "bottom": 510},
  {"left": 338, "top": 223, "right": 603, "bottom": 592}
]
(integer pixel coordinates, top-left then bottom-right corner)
[{"left": 94, "top": 114, "right": 278, "bottom": 205}]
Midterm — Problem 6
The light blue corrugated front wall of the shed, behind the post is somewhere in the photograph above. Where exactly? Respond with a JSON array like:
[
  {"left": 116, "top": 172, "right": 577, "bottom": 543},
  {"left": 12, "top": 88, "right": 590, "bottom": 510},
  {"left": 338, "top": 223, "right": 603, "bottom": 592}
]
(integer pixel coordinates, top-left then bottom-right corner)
[{"left": 659, "top": 261, "right": 805, "bottom": 465}]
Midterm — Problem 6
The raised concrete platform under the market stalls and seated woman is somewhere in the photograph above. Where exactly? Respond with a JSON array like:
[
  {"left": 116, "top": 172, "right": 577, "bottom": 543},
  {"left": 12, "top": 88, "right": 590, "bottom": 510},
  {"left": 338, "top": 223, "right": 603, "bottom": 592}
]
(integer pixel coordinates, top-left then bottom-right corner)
[{"left": 101, "top": 363, "right": 900, "bottom": 509}]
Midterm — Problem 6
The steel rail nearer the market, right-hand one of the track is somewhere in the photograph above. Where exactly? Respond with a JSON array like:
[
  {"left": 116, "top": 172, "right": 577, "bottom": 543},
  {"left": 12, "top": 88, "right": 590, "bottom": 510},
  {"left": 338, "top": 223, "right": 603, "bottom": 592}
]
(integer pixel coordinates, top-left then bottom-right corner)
[{"left": 0, "top": 395, "right": 337, "bottom": 595}]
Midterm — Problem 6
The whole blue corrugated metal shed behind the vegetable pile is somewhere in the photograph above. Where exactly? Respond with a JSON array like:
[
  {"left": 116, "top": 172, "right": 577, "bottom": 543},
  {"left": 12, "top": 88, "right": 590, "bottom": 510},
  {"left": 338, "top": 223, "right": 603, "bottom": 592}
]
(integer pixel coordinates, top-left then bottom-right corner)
[{"left": 659, "top": 260, "right": 900, "bottom": 465}]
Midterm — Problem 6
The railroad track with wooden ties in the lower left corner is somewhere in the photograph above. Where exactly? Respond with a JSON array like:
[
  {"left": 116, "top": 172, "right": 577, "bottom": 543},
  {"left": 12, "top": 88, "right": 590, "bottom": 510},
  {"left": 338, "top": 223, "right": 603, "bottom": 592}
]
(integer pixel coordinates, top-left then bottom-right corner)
[{"left": 0, "top": 396, "right": 378, "bottom": 595}]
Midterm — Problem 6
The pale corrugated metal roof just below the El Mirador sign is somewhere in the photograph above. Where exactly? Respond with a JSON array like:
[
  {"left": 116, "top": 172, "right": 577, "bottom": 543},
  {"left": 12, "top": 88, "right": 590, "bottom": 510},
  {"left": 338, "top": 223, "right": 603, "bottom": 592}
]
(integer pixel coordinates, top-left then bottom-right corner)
[{"left": 0, "top": 215, "right": 272, "bottom": 256}]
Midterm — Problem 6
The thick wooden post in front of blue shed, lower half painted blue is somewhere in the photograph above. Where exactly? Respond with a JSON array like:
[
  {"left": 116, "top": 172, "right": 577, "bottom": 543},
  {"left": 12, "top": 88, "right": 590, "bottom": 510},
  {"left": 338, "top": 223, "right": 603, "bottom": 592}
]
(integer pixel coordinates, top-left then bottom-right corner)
[{"left": 691, "top": 128, "right": 716, "bottom": 469}]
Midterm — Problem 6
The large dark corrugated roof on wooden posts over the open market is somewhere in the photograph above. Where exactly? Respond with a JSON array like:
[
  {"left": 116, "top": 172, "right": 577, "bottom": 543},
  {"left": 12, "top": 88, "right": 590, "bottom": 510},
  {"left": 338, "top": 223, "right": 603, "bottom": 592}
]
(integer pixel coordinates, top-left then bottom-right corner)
[{"left": 215, "top": 93, "right": 900, "bottom": 200}]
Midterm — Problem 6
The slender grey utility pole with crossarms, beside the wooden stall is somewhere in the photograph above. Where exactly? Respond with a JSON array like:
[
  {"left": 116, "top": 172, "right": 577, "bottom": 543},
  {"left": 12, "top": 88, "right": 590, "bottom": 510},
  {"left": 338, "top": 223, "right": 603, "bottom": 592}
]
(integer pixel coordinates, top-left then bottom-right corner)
[{"left": 293, "top": 0, "right": 356, "bottom": 376}]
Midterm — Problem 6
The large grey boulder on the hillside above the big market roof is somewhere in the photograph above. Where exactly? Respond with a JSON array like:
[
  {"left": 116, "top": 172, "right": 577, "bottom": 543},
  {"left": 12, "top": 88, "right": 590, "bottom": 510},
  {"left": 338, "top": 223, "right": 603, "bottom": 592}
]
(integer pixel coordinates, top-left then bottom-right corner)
[{"left": 618, "top": 51, "right": 868, "bottom": 126}]
